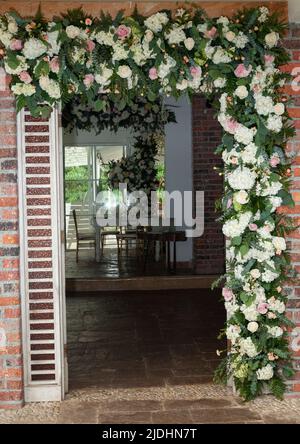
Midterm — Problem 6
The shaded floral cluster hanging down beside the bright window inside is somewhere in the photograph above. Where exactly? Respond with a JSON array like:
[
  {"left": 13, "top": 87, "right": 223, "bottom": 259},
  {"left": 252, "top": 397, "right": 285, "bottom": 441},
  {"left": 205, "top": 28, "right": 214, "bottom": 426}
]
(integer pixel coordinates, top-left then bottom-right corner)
[{"left": 108, "top": 136, "right": 159, "bottom": 196}]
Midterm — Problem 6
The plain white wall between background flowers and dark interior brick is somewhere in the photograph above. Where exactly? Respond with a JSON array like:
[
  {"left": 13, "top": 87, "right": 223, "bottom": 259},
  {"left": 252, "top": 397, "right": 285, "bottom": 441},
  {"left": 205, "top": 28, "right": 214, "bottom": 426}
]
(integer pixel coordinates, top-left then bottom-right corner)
[{"left": 165, "top": 97, "right": 193, "bottom": 261}]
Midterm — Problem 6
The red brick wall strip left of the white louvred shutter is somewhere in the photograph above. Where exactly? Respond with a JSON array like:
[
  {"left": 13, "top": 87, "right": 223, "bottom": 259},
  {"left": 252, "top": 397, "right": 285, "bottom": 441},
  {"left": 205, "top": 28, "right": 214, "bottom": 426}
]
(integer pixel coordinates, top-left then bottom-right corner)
[{"left": 0, "top": 74, "right": 23, "bottom": 408}]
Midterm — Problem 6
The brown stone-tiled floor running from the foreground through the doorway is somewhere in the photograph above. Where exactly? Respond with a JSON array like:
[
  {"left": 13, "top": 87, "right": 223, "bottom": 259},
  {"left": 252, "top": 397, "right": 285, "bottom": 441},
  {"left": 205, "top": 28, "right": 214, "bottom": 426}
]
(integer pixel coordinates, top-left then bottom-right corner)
[{"left": 0, "top": 290, "right": 300, "bottom": 424}]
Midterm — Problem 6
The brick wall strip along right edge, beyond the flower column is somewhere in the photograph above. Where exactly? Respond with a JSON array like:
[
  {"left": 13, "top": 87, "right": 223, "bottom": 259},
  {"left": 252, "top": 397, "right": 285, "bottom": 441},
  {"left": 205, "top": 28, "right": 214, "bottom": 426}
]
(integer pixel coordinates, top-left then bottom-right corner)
[{"left": 283, "top": 24, "right": 300, "bottom": 396}]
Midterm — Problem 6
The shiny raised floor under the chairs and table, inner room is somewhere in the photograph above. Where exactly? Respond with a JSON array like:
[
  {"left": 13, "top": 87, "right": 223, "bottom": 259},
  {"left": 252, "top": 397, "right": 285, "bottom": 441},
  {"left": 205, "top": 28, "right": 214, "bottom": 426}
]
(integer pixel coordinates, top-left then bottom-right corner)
[{"left": 66, "top": 248, "right": 218, "bottom": 293}]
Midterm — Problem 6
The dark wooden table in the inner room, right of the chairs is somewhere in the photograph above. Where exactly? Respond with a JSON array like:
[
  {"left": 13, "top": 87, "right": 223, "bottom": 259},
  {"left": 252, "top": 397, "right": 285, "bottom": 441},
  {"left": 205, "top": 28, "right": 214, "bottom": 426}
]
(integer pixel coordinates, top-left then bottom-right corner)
[{"left": 137, "top": 229, "right": 187, "bottom": 273}]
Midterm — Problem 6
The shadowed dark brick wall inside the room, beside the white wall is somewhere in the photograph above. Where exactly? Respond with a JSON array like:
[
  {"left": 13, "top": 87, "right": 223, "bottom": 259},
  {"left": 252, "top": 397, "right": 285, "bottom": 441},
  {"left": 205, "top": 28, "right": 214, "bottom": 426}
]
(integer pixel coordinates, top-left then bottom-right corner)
[{"left": 193, "top": 96, "right": 225, "bottom": 274}]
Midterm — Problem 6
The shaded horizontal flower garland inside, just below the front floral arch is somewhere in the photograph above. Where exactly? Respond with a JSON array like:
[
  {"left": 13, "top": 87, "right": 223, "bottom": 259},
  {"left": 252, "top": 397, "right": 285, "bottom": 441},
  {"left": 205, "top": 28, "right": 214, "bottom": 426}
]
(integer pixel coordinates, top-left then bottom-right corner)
[{"left": 62, "top": 95, "right": 176, "bottom": 134}]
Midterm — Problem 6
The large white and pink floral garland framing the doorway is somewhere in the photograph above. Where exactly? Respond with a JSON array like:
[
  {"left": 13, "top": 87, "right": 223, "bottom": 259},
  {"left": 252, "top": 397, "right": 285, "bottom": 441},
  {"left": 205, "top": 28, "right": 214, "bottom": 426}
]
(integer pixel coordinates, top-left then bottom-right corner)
[{"left": 0, "top": 7, "right": 294, "bottom": 399}]
